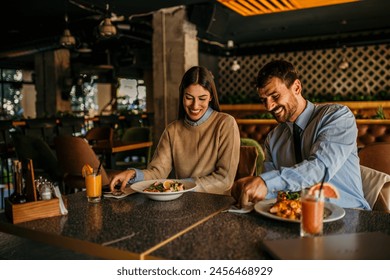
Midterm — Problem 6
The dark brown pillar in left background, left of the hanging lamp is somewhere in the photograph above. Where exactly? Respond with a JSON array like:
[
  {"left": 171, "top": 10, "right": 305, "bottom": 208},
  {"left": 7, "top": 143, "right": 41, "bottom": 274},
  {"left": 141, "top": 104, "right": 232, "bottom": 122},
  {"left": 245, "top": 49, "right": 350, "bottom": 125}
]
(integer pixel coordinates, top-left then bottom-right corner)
[{"left": 35, "top": 49, "right": 72, "bottom": 117}]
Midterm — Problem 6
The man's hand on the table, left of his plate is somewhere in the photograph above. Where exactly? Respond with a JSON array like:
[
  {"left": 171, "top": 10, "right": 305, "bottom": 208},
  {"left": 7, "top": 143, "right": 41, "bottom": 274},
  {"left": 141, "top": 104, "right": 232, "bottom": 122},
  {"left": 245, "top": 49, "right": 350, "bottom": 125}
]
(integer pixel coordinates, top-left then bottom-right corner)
[{"left": 231, "top": 176, "right": 268, "bottom": 208}]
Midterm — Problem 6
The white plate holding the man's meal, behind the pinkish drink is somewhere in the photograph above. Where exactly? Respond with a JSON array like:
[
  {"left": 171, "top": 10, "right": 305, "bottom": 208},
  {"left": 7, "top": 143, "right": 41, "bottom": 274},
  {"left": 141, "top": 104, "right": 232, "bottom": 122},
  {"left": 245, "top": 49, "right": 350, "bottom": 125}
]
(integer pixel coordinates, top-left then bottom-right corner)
[{"left": 255, "top": 198, "right": 345, "bottom": 223}]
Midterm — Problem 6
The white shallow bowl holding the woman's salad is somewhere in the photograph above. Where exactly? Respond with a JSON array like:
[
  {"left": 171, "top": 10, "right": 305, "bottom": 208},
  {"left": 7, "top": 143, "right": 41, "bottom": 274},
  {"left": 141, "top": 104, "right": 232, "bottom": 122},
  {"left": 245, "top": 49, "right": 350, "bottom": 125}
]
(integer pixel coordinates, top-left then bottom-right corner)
[{"left": 131, "top": 179, "right": 196, "bottom": 201}]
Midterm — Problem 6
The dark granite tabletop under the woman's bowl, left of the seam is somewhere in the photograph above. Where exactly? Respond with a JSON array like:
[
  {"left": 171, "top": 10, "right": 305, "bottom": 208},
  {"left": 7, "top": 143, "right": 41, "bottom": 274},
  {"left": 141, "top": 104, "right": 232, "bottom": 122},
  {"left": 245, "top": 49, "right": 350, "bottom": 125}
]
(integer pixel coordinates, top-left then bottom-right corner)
[{"left": 0, "top": 192, "right": 233, "bottom": 259}]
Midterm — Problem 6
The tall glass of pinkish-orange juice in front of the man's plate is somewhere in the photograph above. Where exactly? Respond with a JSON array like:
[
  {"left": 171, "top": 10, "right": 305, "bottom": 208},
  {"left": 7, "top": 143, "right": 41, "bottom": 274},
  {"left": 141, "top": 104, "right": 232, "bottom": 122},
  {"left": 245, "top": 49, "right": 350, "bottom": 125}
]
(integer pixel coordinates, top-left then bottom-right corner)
[{"left": 300, "top": 189, "right": 324, "bottom": 237}]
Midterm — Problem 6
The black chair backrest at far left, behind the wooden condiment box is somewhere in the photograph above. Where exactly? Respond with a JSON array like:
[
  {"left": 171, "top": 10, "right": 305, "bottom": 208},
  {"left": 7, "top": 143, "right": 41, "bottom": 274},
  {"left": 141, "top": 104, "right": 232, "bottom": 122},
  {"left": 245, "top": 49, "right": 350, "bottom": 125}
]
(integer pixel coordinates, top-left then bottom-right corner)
[{"left": 12, "top": 133, "right": 62, "bottom": 182}]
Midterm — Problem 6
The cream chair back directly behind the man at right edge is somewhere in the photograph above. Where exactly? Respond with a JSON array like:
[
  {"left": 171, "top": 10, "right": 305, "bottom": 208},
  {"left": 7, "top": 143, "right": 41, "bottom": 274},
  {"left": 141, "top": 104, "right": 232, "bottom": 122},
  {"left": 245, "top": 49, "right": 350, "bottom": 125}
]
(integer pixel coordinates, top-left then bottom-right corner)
[{"left": 360, "top": 165, "right": 390, "bottom": 211}]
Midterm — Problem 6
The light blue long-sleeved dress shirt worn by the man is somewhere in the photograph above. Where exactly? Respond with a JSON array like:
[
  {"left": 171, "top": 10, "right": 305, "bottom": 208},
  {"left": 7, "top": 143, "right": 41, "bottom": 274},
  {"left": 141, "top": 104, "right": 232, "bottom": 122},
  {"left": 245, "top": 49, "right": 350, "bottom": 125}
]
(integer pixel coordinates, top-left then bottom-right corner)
[{"left": 260, "top": 101, "right": 370, "bottom": 209}]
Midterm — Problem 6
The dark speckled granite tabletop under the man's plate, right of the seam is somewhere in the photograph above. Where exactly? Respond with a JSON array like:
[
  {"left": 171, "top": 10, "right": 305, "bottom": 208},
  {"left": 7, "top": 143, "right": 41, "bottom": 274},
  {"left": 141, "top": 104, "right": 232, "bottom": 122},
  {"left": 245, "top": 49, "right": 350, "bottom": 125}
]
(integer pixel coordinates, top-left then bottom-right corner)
[{"left": 151, "top": 209, "right": 390, "bottom": 260}]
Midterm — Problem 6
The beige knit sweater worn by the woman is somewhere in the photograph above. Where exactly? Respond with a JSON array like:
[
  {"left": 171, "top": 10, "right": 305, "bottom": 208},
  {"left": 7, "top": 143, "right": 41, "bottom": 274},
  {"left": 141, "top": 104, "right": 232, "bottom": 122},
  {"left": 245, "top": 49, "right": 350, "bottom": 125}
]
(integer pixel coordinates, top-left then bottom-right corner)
[{"left": 142, "top": 111, "right": 240, "bottom": 195}]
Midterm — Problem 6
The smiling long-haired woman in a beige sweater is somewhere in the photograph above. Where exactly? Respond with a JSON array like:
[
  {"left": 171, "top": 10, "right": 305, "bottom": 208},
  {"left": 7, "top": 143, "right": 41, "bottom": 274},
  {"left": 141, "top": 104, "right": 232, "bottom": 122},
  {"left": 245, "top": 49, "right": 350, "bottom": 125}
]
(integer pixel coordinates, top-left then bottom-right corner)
[{"left": 110, "top": 66, "right": 240, "bottom": 194}]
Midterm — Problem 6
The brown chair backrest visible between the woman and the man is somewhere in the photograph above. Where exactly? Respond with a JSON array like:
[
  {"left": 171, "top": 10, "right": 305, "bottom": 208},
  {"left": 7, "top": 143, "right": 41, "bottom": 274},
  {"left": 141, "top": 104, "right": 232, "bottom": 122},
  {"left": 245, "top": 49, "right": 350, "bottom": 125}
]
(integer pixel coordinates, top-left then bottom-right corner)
[{"left": 235, "top": 146, "right": 258, "bottom": 180}]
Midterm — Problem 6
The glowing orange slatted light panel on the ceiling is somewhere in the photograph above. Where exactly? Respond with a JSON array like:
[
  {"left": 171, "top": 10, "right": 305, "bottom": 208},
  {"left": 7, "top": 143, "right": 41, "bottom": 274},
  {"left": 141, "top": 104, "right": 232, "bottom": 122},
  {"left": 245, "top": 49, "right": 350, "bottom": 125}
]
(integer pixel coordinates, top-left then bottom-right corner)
[{"left": 218, "top": 0, "right": 361, "bottom": 16}]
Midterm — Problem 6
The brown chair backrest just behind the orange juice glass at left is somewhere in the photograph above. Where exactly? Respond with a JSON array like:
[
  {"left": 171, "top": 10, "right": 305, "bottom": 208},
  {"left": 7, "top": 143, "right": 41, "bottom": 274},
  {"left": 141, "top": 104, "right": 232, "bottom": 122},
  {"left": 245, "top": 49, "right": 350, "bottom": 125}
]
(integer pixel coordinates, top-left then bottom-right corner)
[{"left": 54, "top": 135, "right": 109, "bottom": 188}]
